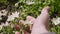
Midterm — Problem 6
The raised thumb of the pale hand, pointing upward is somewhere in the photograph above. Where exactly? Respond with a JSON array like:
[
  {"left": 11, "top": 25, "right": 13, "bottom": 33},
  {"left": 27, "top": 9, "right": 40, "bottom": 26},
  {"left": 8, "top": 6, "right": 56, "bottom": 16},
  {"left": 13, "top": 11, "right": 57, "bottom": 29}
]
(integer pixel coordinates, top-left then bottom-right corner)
[{"left": 37, "top": 6, "right": 50, "bottom": 20}]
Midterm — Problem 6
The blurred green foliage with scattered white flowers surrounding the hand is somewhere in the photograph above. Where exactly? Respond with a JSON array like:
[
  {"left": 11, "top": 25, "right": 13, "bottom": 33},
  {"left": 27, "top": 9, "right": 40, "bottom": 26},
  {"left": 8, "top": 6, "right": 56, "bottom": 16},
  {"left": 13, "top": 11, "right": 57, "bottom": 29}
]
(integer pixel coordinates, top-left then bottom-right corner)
[{"left": 0, "top": 0, "right": 60, "bottom": 34}]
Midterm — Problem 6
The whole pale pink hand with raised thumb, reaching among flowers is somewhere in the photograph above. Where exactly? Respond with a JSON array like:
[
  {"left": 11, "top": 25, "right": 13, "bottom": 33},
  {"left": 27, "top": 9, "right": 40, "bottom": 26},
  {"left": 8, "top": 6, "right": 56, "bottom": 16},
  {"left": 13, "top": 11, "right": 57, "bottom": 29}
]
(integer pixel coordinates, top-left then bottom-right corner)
[{"left": 15, "top": 6, "right": 50, "bottom": 34}]
